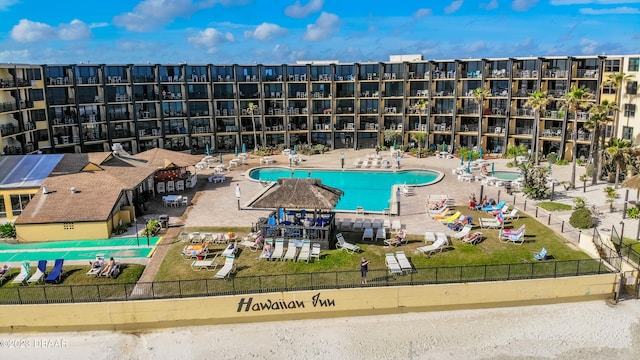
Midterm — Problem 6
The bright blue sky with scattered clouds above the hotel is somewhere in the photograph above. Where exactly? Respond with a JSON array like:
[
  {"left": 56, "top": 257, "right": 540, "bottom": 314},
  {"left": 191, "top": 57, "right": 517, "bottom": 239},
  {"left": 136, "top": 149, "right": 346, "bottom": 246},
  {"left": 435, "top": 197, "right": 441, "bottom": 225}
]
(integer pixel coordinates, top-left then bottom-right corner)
[{"left": 0, "top": 0, "right": 640, "bottom": 64}]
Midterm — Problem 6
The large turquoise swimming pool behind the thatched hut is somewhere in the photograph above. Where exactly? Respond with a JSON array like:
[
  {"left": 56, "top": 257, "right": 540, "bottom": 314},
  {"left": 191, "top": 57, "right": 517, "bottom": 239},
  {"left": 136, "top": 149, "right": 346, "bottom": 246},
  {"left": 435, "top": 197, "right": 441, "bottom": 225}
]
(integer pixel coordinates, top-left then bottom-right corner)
[{"left": 249, "top": 167, "right": 441, "bottom": 211}]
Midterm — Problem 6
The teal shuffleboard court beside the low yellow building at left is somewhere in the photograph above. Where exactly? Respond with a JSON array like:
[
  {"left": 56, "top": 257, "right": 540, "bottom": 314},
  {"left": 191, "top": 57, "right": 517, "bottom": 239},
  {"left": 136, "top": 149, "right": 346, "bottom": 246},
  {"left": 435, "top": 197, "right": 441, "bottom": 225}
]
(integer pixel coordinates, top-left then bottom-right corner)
[{"left": 0, "top": 237, "right": 159, "bottom": 262}]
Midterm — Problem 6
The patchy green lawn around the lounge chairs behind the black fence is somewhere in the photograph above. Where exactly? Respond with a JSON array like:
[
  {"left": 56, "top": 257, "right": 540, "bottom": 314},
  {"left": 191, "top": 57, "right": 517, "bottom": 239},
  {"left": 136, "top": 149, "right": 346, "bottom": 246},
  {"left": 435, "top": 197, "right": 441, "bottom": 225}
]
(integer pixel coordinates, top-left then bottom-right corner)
[{"left": 156, "top": 207, "right": 589, "bottom": 281}]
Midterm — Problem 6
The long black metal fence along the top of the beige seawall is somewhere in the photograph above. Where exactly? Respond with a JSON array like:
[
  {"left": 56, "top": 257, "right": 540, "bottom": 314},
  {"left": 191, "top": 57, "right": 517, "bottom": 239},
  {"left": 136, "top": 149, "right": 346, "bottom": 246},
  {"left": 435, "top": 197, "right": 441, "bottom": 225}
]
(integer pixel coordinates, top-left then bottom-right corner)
[{"left": 0, "top": 259, "right": 613, "bottom": 304}]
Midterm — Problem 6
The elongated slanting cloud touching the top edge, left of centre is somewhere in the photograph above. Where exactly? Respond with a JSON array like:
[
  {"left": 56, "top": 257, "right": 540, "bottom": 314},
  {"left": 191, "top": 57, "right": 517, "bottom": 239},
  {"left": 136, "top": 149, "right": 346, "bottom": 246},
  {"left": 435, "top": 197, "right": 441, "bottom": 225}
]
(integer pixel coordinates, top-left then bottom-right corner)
[{"left": 113, "top": 0, "right": 236, "bottom": 32}]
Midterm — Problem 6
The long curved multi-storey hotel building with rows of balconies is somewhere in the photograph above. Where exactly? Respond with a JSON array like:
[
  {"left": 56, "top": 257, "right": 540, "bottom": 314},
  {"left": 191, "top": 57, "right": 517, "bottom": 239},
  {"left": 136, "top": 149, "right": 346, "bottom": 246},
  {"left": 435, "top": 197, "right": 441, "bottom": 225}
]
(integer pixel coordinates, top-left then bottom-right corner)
[{"left": 0, "top": 55, "right": 640, "bottom": 159}]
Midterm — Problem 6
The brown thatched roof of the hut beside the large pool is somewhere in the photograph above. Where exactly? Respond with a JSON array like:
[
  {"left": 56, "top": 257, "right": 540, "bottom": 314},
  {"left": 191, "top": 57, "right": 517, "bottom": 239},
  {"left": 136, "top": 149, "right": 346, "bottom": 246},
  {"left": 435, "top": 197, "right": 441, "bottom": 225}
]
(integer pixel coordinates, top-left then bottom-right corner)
[{"left": 251, "top": 178, "right": 344, "bottom": 210}]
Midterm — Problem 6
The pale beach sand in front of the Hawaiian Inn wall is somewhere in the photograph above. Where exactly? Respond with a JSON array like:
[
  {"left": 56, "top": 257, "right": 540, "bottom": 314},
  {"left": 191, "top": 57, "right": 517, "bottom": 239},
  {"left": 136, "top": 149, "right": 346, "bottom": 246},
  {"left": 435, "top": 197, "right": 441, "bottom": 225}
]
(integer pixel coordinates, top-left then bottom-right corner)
[{"left": 5, "top": 300, "right": 640, "bottom": 360}]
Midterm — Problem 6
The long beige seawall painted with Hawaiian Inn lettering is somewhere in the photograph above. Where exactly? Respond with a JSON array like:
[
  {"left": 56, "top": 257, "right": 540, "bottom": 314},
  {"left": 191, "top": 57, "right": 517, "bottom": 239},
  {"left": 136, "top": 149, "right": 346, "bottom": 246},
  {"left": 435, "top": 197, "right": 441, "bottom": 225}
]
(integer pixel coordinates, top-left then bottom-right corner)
[{"left": 0, "top": 274, "right": 618, "bottom": 332}]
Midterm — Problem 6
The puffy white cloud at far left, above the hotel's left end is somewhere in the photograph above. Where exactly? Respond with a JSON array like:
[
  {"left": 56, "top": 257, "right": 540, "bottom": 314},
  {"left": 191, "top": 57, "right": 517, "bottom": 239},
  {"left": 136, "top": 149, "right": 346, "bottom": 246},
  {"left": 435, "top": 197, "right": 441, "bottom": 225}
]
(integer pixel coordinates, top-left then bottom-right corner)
[{"left": 11, "top": 19, "right": 91, "bottom": 42}]
